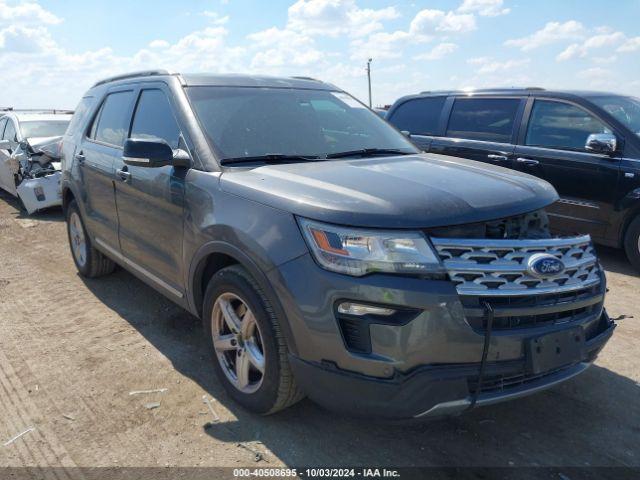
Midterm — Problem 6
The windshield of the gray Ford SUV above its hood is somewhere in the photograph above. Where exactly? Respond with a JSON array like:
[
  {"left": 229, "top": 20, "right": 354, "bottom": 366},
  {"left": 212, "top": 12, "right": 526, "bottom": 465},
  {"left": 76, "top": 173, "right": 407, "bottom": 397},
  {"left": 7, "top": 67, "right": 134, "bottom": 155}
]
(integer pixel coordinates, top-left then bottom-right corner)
[{"left": 187, "top": 87, "right": 418, "bottom": 160}]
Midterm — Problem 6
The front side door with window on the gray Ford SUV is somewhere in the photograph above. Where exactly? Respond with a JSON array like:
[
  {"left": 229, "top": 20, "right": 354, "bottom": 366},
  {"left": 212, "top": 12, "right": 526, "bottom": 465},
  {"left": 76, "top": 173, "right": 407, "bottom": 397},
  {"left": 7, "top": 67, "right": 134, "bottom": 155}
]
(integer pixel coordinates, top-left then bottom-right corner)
[{"left": 115, "top": 85, "right": 187, "bottom": 297}]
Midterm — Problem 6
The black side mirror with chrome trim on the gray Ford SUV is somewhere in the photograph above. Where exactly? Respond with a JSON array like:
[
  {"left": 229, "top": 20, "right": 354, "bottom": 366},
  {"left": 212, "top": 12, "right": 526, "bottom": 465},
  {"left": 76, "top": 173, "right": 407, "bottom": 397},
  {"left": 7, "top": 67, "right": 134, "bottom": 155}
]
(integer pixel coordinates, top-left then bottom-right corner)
[{"left": 122, "top": 138, "right": 191, "bottom": 168}]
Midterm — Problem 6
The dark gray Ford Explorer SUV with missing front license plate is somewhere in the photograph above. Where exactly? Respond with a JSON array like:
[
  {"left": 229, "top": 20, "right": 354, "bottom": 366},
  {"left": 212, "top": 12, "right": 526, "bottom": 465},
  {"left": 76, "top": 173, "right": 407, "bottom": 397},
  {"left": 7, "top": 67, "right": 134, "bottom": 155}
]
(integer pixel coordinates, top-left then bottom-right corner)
[{"left": 62, "top": 71, "right": 614, "bottom": 418}]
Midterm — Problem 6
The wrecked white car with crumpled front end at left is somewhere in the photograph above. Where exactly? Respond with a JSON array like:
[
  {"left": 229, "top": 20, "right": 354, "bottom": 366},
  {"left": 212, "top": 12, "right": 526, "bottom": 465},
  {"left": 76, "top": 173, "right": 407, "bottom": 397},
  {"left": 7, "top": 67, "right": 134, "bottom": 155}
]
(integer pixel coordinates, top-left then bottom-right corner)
[{"left": 0, "top": 109, "right": 72, "bottom": 214}]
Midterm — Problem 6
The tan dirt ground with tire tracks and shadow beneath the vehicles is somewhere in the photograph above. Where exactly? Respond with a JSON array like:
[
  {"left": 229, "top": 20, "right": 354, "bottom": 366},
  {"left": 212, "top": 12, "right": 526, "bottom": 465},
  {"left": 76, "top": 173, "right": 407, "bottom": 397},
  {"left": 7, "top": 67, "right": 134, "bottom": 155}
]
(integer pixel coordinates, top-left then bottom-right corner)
[{"left": 0, "top": 188, "right": 640, "bottom": 468}]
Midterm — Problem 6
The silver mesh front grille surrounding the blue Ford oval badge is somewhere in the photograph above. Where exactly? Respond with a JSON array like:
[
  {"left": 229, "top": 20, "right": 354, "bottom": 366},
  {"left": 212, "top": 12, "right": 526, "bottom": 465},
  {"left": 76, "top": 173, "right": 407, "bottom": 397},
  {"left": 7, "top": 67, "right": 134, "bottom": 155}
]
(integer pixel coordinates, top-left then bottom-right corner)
[{"left": 431, "top": 235, "right": 601, "bottom": 296}]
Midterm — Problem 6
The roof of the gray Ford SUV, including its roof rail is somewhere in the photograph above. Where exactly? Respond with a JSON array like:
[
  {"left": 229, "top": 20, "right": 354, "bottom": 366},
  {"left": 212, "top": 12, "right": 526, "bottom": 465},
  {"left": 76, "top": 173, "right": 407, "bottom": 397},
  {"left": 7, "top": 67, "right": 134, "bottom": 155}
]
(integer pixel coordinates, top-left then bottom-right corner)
[{"left": 94, "top": 70, "right": 339, "bottom": 90}]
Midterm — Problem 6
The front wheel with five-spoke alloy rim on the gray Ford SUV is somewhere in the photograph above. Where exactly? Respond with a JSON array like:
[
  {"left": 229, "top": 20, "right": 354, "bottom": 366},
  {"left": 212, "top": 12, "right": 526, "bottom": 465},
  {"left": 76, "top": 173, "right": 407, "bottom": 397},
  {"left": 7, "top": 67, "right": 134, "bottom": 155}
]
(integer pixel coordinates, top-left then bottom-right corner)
[{"left": 203, "top": 265, "right": 303, "bottom": 415}]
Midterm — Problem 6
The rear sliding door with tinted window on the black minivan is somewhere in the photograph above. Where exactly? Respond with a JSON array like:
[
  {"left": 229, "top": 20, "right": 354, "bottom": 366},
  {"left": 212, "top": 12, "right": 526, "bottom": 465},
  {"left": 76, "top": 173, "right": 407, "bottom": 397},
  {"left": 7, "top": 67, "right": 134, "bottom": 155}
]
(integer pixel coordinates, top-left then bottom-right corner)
[{"left": 430, "top": 96, "right": 526, "bottom": 168}]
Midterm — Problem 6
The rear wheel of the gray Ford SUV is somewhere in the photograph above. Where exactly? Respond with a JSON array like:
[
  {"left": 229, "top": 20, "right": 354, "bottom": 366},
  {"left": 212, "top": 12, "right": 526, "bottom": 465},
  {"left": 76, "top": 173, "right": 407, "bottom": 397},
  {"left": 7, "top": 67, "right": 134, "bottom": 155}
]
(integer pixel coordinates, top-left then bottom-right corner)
[{"left": 66, "top": 200, "right": 116, "bottom": 278}]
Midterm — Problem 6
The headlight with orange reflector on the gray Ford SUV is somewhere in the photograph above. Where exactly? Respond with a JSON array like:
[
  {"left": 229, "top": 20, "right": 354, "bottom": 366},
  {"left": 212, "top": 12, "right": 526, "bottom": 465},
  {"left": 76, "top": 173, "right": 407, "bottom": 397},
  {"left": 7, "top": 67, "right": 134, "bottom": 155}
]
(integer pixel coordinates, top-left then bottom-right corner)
[{"left": 298, "top": 218, "right": 443, "bottom": 277}]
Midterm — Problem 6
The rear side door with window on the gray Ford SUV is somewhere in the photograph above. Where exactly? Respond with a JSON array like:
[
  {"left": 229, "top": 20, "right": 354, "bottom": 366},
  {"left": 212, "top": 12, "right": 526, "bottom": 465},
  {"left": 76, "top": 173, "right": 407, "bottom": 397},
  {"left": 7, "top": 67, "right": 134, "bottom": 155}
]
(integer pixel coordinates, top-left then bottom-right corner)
[{"left": 74, "top": 87, "right": 135, "bottom": 252}]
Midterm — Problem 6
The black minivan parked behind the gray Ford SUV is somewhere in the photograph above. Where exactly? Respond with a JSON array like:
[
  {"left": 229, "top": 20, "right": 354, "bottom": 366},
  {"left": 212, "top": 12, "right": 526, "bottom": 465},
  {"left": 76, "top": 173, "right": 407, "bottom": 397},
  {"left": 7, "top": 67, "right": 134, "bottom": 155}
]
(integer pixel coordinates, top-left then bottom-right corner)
[{"left": 387, "top": 88, "right": 640, "bottom": 269}]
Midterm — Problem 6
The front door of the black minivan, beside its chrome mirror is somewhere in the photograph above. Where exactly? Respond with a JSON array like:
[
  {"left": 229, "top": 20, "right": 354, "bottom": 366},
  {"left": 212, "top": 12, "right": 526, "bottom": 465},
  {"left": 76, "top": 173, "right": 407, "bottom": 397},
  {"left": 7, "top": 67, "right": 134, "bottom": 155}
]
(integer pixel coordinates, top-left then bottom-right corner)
[{"left": 515, "top": 98, "right": 620, "bottom": 239}]
